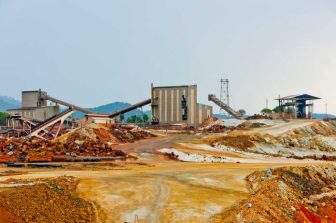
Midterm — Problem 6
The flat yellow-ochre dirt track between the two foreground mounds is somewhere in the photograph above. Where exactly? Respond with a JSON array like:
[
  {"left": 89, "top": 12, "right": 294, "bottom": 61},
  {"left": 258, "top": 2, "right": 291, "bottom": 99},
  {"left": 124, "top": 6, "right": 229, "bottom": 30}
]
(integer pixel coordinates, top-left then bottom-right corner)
[{"left": 2, "top": 162, "right": 290, "bottom": 222}]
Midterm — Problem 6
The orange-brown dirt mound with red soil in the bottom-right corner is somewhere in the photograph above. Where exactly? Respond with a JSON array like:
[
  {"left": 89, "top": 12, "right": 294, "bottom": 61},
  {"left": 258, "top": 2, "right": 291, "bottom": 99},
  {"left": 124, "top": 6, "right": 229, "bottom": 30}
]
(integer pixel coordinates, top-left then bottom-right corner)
[{"left": 213, "top": 165, "right": 336, "bottom": 223}]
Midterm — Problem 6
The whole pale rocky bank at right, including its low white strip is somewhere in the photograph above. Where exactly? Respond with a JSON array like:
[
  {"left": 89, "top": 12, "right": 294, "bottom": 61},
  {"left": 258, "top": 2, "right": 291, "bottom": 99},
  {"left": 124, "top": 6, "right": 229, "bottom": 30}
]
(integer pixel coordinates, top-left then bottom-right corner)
[{"left": 160, "top": 120, "right": 336, "bottom": 163}]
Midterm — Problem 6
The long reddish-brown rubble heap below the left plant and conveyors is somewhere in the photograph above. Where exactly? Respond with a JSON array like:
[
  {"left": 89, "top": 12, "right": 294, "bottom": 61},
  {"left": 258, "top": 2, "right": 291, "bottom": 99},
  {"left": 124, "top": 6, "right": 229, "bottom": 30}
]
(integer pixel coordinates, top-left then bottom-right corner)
[{"left": 0, "top": 124, "right": 154, "bottom": 162}]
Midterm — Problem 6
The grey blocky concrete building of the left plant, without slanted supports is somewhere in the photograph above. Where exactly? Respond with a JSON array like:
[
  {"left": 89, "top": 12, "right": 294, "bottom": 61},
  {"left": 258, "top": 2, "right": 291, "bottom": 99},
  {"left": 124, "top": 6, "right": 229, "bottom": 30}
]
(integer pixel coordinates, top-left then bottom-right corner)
[{"left": 7, "top": 91, "right": 60, "bottom": 122}]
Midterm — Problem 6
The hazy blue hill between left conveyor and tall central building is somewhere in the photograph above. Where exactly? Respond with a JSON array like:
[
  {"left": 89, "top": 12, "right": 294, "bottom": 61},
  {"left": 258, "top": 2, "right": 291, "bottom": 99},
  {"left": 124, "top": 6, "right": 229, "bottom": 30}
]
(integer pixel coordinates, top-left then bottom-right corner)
[{"left": 73, "top": 102, "right": 150, "bottom": 119}]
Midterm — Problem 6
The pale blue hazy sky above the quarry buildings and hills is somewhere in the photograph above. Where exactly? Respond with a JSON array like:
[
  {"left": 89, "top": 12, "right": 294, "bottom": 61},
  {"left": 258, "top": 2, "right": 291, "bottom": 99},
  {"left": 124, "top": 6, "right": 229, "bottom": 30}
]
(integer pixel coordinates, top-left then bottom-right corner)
[{"left": 0, "top": 0, "right": 336, "bottom": 114}]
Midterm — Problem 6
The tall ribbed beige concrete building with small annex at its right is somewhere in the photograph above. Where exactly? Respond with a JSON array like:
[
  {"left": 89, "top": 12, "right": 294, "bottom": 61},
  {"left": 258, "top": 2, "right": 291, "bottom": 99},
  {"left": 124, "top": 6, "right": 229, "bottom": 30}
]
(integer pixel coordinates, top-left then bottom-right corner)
[{"left": 151, "top": 84, "right": 212, "bottom": 127}]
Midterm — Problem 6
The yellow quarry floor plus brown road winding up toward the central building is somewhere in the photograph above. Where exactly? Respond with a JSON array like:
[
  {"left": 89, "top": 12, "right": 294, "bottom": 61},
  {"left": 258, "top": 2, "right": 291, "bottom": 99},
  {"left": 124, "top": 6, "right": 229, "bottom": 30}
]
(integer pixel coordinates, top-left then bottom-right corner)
[{"left": 0, "top": 127, "right": 325, "bottom": 223}]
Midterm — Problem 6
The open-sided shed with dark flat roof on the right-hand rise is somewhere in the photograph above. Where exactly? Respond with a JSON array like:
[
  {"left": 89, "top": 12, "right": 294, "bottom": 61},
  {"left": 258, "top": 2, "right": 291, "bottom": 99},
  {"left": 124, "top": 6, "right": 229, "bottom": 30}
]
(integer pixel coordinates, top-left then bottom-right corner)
[{"left": 275, "top": 94, "right": 321, "bottom": 119}]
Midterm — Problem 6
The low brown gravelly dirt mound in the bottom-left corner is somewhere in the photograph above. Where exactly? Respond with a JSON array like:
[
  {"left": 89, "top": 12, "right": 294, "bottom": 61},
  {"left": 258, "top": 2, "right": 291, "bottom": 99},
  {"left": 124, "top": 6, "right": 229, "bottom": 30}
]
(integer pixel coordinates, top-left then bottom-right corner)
[{"left": 0, "top": 177, "right": 98, "bottom": 223}]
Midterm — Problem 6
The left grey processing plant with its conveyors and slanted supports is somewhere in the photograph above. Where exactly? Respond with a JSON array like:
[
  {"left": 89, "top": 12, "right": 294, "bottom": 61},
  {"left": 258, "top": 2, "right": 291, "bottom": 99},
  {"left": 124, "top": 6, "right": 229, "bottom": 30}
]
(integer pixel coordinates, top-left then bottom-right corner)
[{"left": 2, "top": 90, "right": 90, "bottom": 138}]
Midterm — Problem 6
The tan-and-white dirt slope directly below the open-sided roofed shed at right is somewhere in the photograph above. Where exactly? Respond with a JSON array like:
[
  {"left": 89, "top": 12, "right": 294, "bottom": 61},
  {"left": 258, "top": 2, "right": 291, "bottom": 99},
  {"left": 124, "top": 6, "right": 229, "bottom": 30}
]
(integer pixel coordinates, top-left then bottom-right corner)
[{"left": 211, "top": 121, "right": 336, "bottom": 161}]
